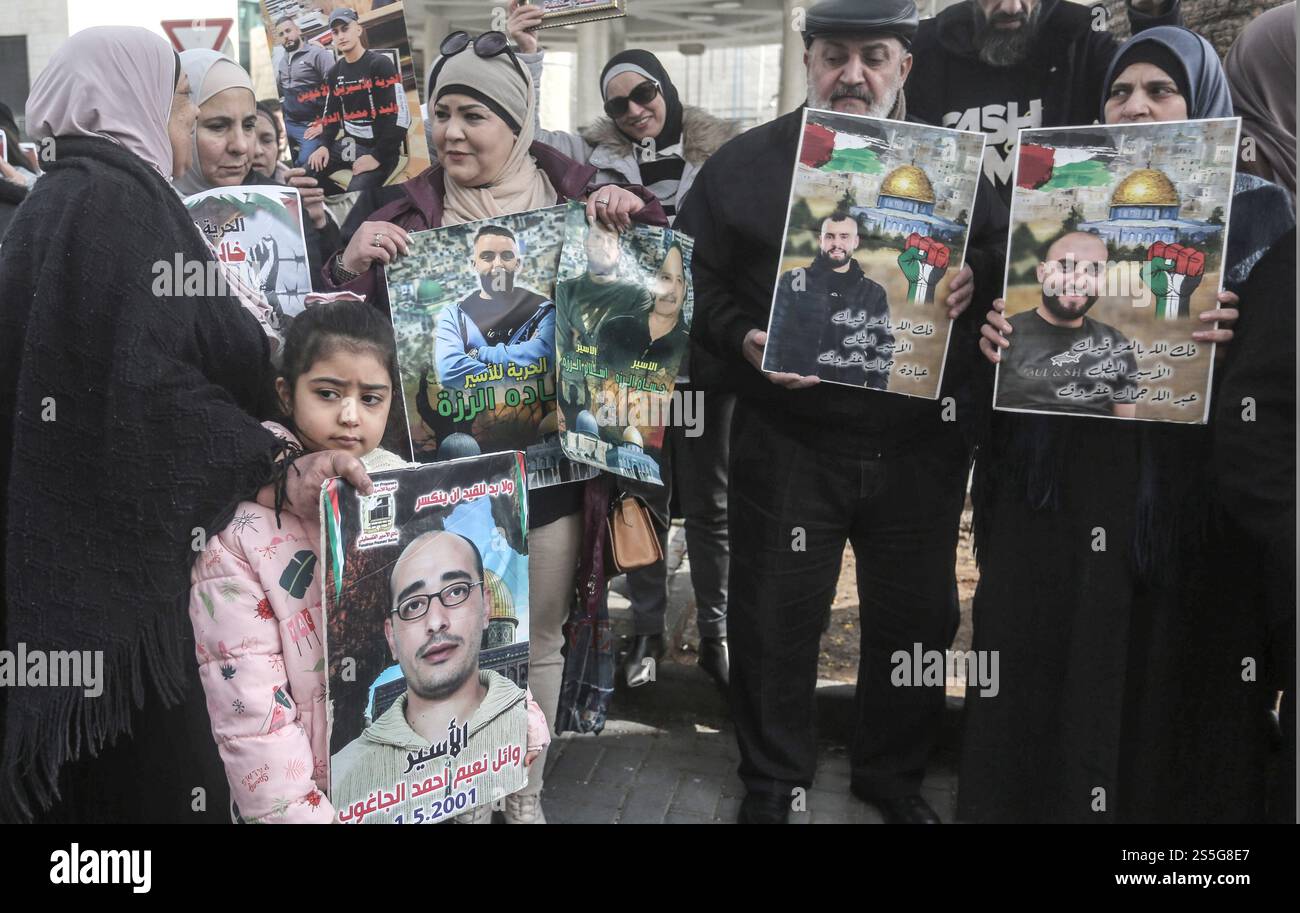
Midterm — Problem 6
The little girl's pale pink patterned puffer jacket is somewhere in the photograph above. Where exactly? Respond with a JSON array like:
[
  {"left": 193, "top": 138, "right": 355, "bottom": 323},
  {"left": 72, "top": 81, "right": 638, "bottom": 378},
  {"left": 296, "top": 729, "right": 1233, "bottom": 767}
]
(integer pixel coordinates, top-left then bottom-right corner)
[{"left": 190, "top": 421, "right": 550, "bottom": 823}]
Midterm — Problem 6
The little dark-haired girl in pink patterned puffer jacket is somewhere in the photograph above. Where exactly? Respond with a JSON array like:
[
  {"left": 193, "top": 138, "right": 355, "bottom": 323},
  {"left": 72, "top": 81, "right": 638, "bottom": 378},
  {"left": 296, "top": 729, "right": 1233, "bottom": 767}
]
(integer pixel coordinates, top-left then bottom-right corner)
[{"left": 190, "top": 300, "right": 550, "bottom": 823}]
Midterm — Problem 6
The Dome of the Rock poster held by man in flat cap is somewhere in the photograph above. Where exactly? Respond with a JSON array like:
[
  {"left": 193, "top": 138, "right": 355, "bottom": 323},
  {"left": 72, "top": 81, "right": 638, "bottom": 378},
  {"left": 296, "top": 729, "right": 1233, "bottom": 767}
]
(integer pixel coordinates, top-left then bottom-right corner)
[{"left": 763, "top": 108, "right": 984, "bottom": 399}]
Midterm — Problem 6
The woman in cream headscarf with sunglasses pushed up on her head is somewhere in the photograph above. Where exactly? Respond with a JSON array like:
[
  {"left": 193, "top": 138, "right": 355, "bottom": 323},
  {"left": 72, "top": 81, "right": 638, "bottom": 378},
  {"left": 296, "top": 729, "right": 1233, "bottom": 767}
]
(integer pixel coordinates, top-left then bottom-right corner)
[{"left": 318, "top": 33, "right": 667, "bottom": 823}]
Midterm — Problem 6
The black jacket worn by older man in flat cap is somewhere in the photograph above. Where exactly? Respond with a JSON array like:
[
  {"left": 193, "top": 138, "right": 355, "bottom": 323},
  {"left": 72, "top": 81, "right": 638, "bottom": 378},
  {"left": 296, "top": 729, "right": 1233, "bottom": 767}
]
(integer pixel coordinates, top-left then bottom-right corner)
[{"left": 675, "top": 104, "right": 1008, "bottom": 451}]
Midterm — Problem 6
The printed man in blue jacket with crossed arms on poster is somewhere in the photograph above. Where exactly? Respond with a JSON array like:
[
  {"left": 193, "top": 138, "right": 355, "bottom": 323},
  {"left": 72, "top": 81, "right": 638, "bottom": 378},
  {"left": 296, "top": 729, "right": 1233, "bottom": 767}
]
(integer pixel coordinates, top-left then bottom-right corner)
[{"left": 437, "top": 225, "right": 555, "bottom": 390}]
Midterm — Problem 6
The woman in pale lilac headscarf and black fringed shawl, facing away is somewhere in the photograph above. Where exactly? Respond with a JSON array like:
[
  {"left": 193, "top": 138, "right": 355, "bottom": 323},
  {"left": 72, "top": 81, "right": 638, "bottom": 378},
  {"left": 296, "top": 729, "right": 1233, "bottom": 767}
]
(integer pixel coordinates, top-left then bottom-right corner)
[{"left": 0, "top": 27, "right": 369, "bottom": 822}]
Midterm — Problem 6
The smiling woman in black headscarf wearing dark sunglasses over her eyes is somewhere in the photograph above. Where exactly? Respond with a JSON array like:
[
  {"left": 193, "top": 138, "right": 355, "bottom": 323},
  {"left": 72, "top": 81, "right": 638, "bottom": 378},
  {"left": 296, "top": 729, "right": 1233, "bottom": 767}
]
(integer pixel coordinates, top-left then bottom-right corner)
[{"left": 506, "top": 0, "right": 740, "bottom": 220}]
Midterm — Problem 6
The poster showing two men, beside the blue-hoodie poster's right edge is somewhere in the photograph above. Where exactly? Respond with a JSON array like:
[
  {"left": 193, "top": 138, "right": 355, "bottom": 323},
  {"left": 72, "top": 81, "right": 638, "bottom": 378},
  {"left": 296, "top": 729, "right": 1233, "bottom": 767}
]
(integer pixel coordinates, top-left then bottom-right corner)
[{"left": 555, "top": 203, "right": 694, "bottom": 485}]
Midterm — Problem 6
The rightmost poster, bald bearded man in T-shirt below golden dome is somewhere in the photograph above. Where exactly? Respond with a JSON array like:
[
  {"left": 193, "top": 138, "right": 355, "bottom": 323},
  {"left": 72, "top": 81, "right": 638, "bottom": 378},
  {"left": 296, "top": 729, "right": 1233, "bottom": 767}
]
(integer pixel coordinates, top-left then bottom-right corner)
[{"left": 993, "top": 117, "right": 1240, "bottom": 424}]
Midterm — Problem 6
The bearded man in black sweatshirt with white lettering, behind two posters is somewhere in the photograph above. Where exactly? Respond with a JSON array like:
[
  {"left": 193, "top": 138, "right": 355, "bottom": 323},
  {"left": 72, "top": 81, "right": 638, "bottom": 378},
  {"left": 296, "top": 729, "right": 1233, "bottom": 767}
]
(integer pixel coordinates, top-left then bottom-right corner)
[{"left": 907, "top": 0, "right": 1182, "bottom": 204}]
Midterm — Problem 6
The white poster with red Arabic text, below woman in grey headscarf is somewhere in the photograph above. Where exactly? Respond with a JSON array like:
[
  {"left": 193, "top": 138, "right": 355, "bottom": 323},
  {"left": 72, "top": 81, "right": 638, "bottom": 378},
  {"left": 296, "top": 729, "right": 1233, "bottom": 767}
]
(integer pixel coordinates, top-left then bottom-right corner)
[{"left": 185, "top": 186, "right": 312, "bottom": 332}]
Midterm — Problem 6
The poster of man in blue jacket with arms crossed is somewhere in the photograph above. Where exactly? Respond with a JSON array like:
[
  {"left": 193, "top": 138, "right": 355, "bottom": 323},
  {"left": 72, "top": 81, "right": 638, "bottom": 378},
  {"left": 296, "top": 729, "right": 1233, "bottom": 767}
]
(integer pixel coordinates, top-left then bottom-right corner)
[{"left": 384, "top": 207, "right": 595, "bottom": 488}]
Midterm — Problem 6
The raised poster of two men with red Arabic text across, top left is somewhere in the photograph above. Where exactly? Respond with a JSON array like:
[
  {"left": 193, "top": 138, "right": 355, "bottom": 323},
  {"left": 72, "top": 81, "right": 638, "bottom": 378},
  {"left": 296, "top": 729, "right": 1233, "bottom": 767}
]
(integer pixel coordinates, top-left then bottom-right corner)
[{"left": 260, "top": 0, "right": 429, "bottom": 198}]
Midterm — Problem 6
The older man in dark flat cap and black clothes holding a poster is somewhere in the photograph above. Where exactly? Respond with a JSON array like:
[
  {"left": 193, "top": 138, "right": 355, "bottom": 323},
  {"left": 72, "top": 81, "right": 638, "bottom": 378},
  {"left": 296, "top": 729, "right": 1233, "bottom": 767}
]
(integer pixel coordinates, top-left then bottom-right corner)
[{"left": 676, "top": 0, "right": 1006, "bottom": 823}]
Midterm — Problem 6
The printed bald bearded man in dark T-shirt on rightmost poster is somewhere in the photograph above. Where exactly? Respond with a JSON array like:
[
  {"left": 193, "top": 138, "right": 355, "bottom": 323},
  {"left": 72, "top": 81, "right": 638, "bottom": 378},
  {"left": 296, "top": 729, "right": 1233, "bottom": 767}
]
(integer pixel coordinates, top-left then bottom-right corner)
[{"left": 997, "top": 232, "right": 1138, "bottom": 419}]
